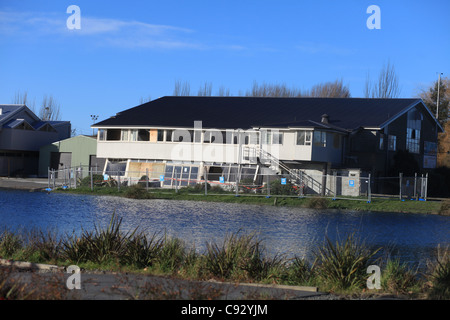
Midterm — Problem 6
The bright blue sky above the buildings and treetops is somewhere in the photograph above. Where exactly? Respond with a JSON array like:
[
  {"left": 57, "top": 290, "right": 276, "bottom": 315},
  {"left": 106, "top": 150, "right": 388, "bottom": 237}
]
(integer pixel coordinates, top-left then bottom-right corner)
[{"left": 0, "top": 0, "right": 450, "bottom": 134}]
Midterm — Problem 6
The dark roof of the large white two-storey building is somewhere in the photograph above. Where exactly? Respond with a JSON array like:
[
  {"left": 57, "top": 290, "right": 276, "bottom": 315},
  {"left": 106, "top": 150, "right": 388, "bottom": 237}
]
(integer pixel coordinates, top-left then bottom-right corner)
[{"left": 93, "top": 96, "right": 431, "bottom": 130}]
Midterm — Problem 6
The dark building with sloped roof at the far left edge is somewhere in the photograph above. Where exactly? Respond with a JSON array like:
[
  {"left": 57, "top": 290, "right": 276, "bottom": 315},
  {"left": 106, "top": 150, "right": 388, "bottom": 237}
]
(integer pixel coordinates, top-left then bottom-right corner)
[{"left": 0, "top": 104, "right": 71, "bottom": 176}]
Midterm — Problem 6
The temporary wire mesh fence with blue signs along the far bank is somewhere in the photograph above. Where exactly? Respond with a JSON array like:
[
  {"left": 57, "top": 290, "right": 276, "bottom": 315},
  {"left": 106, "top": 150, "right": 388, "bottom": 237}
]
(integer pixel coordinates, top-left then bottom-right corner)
[{"left": 48, "top": 164, "right": 428, "bottom": 202}]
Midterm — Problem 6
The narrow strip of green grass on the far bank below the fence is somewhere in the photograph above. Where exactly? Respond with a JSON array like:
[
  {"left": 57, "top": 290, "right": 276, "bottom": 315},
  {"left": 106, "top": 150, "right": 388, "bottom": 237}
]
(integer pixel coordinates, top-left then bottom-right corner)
[{"left": 54, "top": 182, "right": 450, "bottom": 215}]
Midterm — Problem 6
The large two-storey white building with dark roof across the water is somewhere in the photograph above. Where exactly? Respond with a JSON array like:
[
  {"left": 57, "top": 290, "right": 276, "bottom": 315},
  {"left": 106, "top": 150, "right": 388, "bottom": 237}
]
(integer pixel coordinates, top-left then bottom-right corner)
[{"left": 92, "top": 97, "right": 443, "bottom": 191}]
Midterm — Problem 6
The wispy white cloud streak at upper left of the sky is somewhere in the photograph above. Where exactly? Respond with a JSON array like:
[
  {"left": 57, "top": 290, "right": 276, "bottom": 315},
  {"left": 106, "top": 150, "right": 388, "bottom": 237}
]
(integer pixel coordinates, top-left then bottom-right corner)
[{"left": 0, "top": 11, "right": 202, "bottom": 49}]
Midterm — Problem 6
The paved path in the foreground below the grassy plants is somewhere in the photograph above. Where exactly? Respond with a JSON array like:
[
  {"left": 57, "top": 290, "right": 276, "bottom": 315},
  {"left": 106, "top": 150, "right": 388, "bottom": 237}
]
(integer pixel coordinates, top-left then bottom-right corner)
[{"left": 0, "top": 259, "right": 325, "bottom": 300}]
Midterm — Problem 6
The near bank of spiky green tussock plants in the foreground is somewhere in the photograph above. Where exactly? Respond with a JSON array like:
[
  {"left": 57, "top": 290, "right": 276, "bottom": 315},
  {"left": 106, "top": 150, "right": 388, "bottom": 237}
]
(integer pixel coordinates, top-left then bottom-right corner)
[{"left": 0, "top": 215, "right": 450, "bottom": 299}]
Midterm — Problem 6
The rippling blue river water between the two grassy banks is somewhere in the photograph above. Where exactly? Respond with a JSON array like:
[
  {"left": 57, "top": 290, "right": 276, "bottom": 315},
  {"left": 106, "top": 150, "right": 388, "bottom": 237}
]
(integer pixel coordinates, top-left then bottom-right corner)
[{"left": 0, "top": 190, "right": 450, "bottom": 263}]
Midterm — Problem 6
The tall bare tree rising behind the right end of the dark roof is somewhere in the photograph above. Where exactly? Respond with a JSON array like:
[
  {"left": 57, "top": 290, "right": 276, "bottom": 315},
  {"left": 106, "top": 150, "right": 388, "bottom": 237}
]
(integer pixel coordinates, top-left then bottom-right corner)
[{"left": 364, "top": 62, "right": 400, "bottom": 98}]
